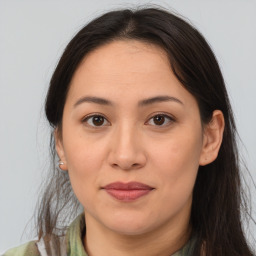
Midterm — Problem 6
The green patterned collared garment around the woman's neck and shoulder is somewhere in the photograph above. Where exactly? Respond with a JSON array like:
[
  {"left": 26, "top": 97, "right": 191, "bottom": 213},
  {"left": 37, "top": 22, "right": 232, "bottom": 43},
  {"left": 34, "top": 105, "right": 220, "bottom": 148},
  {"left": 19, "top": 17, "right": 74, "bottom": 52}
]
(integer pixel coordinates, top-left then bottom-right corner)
[{"left": 3, "top": 213, "right": 194, "bottom": 256}]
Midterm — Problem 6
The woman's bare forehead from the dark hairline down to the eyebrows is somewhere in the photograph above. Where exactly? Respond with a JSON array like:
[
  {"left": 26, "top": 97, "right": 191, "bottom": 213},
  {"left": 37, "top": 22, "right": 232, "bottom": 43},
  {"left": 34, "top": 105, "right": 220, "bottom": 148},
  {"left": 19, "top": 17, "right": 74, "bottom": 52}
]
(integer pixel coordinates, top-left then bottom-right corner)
[{"left": 68, "top": 40, "right": 194, "bottom": 107}]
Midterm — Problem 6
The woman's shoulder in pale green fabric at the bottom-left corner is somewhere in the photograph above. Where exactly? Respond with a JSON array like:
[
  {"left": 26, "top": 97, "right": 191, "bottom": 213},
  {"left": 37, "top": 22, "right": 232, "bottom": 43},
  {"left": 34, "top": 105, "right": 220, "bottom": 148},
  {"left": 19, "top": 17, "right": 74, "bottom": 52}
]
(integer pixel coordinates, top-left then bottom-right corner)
[{"left": 3, "top": 241, "right": 40, "bottom": 256}]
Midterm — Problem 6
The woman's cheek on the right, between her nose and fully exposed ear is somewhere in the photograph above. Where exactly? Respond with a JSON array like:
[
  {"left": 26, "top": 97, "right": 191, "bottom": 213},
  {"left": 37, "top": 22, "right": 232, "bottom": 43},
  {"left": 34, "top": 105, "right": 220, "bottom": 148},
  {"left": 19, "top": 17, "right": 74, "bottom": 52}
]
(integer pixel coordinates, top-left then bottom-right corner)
[{"left": 152, "top": 132, "right": 201, "bottom": 198}]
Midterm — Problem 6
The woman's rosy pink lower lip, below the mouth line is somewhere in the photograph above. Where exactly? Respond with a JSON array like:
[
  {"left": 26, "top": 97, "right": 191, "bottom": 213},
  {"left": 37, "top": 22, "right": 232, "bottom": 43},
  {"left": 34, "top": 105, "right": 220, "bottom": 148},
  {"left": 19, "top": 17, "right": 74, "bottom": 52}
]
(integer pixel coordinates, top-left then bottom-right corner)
[{"left": 105, "top": 189, "right": 152, "bottom": 202}]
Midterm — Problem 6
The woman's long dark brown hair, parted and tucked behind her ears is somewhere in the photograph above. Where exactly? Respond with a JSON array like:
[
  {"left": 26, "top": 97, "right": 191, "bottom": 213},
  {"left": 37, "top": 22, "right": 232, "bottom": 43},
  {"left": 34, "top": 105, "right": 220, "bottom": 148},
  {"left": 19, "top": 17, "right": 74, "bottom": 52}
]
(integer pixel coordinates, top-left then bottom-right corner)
[{"left": 34, "top": 8, "right": 253, "bottom": 256}]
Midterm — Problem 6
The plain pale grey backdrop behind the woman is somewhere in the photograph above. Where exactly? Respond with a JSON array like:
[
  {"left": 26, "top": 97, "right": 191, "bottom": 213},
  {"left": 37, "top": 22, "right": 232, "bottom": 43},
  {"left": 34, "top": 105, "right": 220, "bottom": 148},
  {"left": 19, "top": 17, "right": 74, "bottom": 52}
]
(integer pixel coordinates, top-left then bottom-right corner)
[{"left": 0, "top": 0, "right": 256, "bottom": 253}]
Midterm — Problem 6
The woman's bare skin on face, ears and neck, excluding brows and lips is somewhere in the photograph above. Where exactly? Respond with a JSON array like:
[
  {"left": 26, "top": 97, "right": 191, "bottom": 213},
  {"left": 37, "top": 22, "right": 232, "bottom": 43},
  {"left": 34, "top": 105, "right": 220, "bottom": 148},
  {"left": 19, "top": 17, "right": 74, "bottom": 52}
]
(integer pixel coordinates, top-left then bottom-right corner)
[{"left": 55, "top": 40, "right": 224, "bottom": 256}]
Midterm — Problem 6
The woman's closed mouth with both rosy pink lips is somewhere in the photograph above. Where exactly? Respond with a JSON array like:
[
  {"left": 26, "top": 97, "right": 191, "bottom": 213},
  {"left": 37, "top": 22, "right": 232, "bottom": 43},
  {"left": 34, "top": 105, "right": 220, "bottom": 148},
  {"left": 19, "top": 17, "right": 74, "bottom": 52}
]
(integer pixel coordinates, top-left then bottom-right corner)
[{"left": 102, "top": 182, "right": 154, "bottom": 202}]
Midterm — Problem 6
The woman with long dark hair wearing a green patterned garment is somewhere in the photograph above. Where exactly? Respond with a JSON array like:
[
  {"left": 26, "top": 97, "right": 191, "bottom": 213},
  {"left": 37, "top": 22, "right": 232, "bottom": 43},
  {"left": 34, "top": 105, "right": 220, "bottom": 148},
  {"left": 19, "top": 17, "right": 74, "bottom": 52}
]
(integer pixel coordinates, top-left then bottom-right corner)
[{"left": 5, "top": 5, "right": 253, "bottom": 256}]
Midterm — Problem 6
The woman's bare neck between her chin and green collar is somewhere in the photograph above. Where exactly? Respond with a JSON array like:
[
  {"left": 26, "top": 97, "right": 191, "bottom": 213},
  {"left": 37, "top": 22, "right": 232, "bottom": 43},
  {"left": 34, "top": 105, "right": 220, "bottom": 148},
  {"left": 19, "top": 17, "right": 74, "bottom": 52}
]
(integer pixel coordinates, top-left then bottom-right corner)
[{"left": 84, "top": 216, "right": 191, "bottom": 256}]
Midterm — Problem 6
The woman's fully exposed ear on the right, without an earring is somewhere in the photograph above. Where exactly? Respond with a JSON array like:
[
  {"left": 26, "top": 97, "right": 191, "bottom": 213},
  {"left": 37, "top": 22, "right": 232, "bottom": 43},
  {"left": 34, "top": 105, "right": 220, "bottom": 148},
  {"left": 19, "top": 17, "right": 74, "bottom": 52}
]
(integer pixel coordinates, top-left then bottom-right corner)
[{"left": 199, "top": 110, "right": 225, "bottom": 166}]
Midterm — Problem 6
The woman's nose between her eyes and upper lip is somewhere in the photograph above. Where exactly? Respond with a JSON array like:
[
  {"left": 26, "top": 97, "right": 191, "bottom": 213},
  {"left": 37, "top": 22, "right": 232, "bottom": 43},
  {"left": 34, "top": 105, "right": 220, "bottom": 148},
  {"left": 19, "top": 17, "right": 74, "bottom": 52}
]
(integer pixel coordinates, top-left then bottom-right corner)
[{"left": 108, "top": 125, "right": 147, "bottom": 170}]
